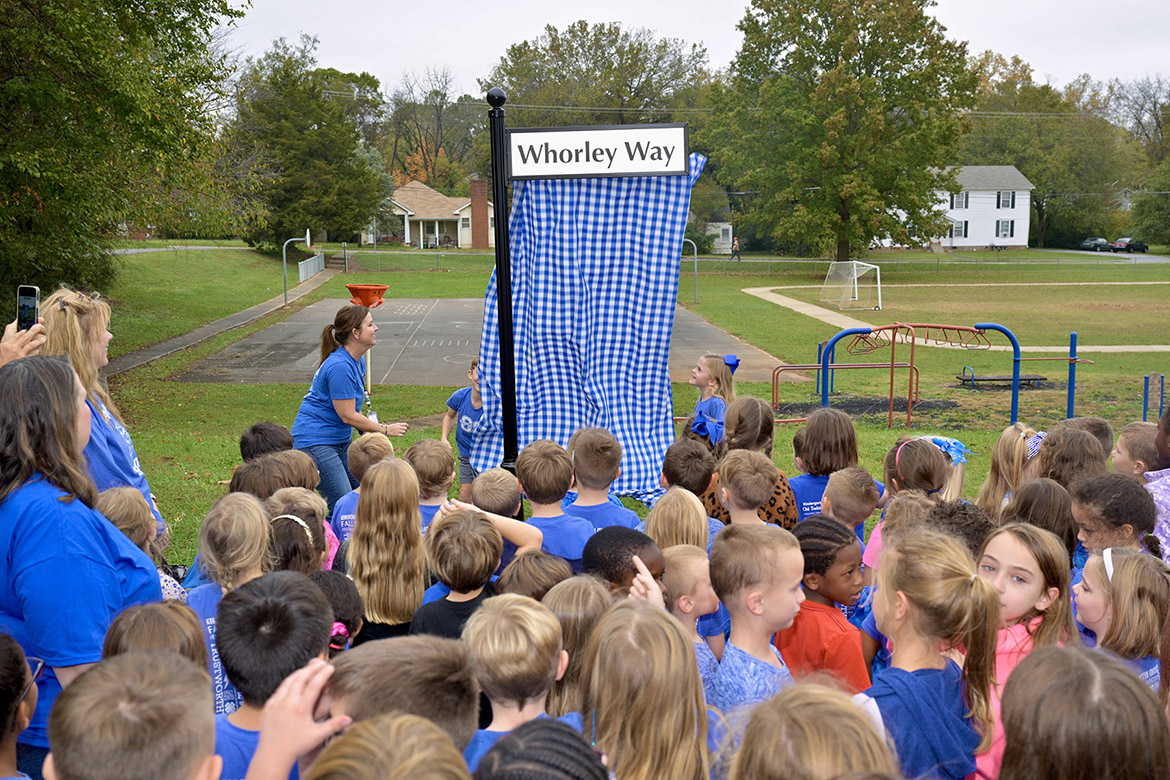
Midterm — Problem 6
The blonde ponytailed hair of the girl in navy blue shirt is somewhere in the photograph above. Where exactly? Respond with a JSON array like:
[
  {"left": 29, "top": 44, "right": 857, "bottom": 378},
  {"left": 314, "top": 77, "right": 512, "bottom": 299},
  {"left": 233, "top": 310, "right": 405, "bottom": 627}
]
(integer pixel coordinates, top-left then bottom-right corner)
[{"left": 878, "top": 529, "right": 999, "bottom": 752}]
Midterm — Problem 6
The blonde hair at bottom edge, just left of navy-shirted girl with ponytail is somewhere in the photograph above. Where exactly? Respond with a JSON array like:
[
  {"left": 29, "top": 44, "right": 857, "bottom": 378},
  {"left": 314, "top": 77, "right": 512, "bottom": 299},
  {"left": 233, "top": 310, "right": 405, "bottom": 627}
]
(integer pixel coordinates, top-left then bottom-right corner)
[{"left": 729, "top": 683, "right": 900, "bottom": 780}]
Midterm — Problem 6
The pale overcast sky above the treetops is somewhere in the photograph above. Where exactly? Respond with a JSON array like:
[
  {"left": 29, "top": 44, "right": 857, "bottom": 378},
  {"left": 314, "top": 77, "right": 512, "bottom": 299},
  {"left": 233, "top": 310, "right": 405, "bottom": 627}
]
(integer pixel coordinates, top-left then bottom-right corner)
[{"left": 223, "top": 0, "right": 1170, "bottom": 95}]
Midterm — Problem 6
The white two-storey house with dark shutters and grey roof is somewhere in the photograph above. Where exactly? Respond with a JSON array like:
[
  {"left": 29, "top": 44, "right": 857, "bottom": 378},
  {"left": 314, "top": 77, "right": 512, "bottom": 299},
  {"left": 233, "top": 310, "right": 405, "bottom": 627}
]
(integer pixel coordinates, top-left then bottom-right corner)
[{"left": 934, "top": 165, "right": 1035, "bottom": 249}]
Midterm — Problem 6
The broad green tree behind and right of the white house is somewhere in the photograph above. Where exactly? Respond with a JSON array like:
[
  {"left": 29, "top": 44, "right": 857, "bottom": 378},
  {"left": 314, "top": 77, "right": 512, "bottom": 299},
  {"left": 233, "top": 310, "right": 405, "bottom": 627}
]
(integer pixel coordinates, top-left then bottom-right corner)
[{"left": 961, "top": 51, "right": 1140, "bottom": 247}]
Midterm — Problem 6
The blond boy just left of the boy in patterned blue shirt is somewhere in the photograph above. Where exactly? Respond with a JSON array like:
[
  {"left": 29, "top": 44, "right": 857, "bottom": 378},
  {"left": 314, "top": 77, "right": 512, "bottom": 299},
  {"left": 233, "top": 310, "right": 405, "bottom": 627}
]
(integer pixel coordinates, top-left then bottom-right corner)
[{"left": 662, "top": 545, "right": 720, "bottom": 699}]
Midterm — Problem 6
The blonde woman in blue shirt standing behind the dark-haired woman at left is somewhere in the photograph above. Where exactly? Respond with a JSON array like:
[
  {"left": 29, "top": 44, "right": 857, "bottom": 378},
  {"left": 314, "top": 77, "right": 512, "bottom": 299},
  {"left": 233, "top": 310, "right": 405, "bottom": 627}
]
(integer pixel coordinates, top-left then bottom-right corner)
[{"left": 41, "top": 288, "right": 167, "bottom": 540}]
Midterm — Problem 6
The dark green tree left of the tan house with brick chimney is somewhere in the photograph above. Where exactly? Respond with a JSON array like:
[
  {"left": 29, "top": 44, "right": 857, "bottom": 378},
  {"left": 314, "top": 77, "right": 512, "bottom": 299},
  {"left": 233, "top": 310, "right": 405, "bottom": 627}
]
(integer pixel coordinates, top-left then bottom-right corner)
[{"left": 227, "top": 36, "right": 385, "bottom": 244}]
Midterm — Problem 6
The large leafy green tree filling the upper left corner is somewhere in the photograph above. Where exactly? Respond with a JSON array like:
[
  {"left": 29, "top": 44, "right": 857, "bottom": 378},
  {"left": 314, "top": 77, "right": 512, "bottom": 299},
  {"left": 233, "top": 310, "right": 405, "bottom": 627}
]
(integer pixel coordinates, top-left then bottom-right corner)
[{"left": 0, "top": 0, "right": 242, "bottom": 290}]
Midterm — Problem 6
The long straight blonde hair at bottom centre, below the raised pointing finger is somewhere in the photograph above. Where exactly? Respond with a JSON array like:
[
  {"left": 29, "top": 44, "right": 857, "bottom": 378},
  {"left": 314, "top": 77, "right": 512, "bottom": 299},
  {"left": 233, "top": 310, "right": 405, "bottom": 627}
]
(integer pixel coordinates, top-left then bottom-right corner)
[{"left": 581, "top": 599, "right": 710, "bottom": 780}]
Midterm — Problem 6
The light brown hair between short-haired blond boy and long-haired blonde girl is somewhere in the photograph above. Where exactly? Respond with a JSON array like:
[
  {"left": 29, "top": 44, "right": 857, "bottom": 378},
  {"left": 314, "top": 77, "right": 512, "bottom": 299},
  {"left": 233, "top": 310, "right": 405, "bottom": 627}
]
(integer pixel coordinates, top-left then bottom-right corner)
[{"left": 540, "top": 573, "right": 613, "bottom": 718}]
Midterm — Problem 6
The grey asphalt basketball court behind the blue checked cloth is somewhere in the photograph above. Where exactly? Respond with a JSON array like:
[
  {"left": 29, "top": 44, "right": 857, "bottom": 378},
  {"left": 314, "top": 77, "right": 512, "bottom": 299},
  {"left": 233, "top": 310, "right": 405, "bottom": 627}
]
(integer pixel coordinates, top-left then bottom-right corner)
[{"left": 180, "top": 298, "right": 801, "bottom": 386}]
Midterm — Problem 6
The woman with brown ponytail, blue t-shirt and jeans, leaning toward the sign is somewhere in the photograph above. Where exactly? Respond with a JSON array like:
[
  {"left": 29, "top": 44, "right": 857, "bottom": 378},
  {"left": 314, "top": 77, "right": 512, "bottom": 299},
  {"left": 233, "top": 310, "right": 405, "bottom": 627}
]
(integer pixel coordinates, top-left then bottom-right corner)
[{"left": 293, "top": 306, "right": 410, "bottom": 512}]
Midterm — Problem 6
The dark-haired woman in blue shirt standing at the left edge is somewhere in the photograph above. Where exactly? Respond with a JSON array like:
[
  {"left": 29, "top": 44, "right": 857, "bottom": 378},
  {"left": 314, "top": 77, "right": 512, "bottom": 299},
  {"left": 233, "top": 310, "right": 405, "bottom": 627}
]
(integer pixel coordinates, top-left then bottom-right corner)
[{"left": 0, "top": 357, "right": 163, "bottom": 778}]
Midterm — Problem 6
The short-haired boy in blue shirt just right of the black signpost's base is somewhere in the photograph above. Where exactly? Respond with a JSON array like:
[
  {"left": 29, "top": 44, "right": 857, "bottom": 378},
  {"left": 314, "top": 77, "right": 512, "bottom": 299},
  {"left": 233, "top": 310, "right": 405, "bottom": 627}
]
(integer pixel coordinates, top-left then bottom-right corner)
[{"left": 516, "top": 439, "right": 593, "bottom": 574}]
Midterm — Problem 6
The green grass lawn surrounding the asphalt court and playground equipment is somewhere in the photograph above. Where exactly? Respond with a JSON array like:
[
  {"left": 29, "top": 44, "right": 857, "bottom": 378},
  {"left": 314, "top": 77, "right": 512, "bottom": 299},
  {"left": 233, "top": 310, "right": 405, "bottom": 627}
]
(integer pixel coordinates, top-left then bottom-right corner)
[{"left": 110, "top": 251, "right": 1170, "bottom": 562}]
